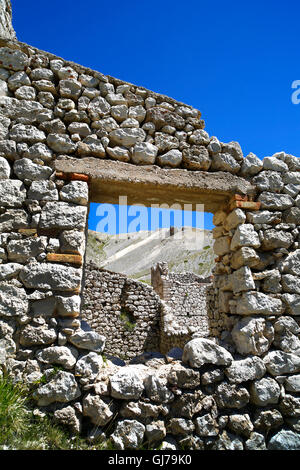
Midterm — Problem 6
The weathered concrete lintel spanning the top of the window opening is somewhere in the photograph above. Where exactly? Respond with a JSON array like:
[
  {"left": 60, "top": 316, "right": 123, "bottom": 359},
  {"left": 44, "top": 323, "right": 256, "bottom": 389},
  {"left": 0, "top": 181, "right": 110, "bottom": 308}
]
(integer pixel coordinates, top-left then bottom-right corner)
[{"left": 55, "top": 157, "right": 254, "bottom": 213}]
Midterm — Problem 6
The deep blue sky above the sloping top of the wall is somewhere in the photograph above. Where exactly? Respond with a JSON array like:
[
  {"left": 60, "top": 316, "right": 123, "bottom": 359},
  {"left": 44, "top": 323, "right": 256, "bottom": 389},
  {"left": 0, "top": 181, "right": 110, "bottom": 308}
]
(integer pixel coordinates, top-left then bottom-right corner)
[{"left": 12, "top": 0, "right": 300, "bottom": 231}]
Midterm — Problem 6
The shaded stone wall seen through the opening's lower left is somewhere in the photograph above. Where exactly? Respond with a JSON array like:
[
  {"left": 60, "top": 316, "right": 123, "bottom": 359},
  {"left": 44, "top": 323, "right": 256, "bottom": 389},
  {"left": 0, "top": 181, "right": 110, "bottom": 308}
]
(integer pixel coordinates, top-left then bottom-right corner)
[{"left": 81, "top": 264, "right": 161, "bottom": 359}]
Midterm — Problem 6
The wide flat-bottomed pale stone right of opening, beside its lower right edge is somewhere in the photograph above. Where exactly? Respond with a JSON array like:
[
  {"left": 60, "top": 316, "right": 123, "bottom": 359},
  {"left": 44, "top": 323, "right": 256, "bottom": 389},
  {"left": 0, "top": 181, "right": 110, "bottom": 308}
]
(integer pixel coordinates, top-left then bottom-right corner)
[{"left": 236, "top": 291, "right": 283, "bottom": 315}]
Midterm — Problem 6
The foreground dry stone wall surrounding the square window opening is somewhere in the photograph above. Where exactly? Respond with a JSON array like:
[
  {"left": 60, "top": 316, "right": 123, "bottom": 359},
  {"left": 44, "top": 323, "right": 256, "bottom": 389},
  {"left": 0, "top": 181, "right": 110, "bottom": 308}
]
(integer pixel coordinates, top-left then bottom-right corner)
[{"left": 0, "top": 34, "right": 300, "bottom": 449}]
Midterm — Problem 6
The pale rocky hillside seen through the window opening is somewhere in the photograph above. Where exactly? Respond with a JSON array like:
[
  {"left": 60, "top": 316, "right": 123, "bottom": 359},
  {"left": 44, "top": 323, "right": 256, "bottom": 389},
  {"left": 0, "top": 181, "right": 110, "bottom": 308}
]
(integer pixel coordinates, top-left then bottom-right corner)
[{"left": 86, "top": 228, "right": 215, "bottom": 282}]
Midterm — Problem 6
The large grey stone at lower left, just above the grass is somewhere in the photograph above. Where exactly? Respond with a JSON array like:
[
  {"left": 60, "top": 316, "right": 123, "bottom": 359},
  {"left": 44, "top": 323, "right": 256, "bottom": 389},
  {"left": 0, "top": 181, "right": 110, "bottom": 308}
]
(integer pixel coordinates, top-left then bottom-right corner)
[{"left": 34, "top": 371, "right": 81, "bottom": 406}]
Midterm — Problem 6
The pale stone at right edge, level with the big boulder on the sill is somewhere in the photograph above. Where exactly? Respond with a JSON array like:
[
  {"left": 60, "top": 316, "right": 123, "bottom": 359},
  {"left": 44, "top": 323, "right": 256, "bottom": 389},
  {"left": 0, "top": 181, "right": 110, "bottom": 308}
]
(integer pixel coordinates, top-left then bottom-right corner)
[{"left": 263, "top": 351, "right": 300, "bottom": 375}]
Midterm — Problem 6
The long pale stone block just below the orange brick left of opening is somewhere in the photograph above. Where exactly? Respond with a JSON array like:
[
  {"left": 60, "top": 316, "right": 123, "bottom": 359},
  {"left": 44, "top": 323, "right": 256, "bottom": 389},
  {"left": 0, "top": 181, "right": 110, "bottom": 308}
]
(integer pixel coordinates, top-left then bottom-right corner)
[{"left": 20, "top": 263, "right": 82, "bottom": 292}]
